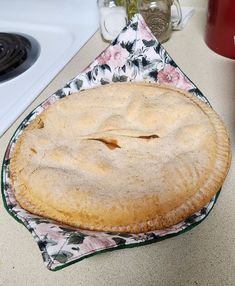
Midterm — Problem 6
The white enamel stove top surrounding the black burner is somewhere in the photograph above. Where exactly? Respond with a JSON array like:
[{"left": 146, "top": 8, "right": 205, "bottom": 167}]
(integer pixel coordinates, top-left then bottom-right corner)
[{"left": 0, "top": 0, "right": 98, "bottom": 135}]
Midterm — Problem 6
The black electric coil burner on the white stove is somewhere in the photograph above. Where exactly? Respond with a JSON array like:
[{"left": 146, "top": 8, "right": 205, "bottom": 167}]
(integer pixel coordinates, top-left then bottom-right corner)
[{"left": 0, "top": 33, "right": 40, "bottom": 82}]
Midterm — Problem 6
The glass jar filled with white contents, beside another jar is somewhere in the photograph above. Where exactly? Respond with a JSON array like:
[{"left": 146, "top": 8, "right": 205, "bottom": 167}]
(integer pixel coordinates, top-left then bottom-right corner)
[{"left": 97, "top": 0, "right": 127, "bottom": 42}]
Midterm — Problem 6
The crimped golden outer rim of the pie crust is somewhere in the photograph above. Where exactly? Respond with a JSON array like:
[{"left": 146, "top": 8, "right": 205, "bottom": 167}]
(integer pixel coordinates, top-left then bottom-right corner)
[{"left": 10, "top": 83, "right": 231, "bottom": 233}]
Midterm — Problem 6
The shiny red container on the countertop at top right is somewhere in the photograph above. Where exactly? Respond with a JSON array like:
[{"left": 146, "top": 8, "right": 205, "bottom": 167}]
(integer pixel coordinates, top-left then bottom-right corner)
[{"left": 205, "top": 0, "right": 235, "bottom": 59}]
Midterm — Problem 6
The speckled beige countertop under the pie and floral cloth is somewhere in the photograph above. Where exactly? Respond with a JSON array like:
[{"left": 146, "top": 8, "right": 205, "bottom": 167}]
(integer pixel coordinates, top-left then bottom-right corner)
[{"left": 0, "top": 0, "right": 235, "bottom": 286}]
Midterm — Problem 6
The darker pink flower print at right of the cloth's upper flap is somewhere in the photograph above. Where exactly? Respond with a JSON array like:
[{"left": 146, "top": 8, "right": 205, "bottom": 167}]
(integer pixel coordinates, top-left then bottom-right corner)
[{"left": 157, "top": 64, "right": 193, "bottom": 90}]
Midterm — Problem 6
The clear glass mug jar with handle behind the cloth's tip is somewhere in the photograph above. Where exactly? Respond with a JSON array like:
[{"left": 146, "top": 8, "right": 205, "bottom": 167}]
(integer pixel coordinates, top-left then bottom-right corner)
[{"left": 137, "top": 0, "right": 182, "bottom": 43}]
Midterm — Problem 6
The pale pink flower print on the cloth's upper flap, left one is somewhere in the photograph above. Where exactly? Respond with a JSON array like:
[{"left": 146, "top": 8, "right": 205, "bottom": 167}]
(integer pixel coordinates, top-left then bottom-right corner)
[{"left": 97, "top": 45, "right": 129, "bottom": 67}]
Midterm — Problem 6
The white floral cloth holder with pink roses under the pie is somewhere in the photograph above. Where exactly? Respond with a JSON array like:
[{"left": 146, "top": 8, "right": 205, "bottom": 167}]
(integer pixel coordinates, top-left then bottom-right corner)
[{"left": 2, "top": 14, "right": 216, "bottom": 270}]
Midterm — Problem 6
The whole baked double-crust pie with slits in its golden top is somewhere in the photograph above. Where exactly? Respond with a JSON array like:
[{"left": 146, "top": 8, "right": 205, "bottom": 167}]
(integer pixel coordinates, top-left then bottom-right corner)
[{"left": 10, "top": 83, "right": 231, "bottom": 233}]
